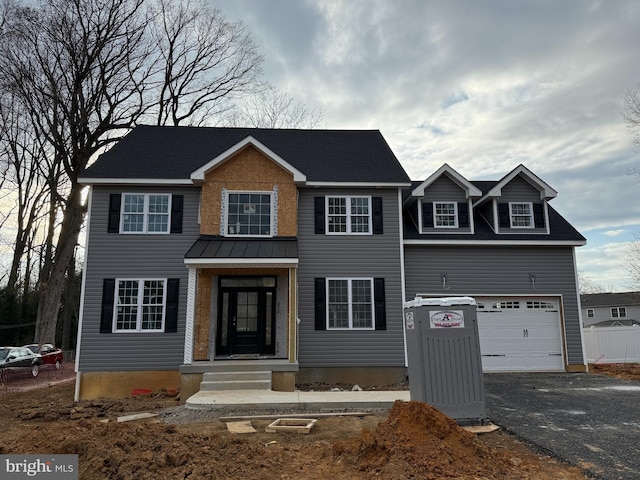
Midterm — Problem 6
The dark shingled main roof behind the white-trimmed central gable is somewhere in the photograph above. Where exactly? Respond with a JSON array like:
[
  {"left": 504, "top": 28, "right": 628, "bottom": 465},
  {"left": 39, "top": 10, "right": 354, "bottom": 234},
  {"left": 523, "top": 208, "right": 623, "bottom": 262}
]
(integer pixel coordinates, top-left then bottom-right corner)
[{"left": 80, "top": 125, "right": 409, "bottom": 184}]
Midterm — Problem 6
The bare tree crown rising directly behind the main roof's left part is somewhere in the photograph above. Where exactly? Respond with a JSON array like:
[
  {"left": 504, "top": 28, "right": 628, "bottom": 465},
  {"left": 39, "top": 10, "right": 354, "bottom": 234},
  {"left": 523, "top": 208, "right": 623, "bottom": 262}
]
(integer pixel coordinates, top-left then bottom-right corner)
[{"left": 151, "top": 0, "right": 262, "bottom": 125}]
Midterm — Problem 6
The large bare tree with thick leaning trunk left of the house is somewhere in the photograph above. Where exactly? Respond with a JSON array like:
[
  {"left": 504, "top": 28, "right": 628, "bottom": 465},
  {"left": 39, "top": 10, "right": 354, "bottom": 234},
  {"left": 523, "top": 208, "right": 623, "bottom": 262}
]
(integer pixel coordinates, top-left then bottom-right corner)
[{"left": 0, "top": 0, "right": 149, "bottom": 342}]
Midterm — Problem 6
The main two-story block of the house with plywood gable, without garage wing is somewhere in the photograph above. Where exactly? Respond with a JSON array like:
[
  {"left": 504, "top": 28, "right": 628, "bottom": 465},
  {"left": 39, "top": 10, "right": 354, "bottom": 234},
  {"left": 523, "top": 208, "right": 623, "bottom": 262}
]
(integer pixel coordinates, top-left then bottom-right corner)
[{"left": 77, "top": 126, "right": 410, "bottom": 398}]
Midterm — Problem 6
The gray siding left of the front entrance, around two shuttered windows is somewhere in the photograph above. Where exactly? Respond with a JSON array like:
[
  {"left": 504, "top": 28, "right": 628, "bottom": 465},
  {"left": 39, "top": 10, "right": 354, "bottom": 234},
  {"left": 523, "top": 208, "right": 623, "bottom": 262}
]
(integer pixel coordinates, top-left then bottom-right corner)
[{"left": 78, "top": 186, "right": 200, "bottom": 372}]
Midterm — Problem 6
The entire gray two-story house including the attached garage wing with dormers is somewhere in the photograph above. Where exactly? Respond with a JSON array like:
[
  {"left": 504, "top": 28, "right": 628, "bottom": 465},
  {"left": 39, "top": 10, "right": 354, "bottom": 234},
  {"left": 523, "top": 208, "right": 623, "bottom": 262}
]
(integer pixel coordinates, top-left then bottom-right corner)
[{"left": 76, "top": 126, "right": 585, "bottom": 399}]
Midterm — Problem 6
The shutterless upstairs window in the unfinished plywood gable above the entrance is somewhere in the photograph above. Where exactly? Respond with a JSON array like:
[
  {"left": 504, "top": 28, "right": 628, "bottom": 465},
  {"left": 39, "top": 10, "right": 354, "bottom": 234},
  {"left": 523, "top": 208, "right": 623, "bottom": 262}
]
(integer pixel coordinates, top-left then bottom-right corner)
[{"left": 224, "top": 192, "right": 274, "bottom": 237}]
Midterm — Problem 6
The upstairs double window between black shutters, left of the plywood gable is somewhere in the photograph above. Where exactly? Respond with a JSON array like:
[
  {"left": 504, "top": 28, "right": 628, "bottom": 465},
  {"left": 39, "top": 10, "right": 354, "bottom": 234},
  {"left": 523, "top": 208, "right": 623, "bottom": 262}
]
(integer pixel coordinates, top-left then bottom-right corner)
[{"left": 120, "top": 193, "right": 171, "bottom": 233}]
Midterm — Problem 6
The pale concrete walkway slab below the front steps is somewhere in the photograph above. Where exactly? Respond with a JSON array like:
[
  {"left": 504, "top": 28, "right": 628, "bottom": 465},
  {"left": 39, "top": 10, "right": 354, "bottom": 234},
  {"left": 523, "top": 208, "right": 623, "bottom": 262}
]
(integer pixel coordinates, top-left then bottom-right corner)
[{"left": 185, "top": 390, "right": 410, "bottom": 411}]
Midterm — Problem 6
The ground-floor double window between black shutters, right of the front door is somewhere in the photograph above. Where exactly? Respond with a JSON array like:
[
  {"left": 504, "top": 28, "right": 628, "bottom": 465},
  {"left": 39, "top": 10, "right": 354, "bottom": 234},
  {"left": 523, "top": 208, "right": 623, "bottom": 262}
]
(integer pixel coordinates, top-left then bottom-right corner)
[{"left": 327, "top": 278, "right": 375, "bottom": 330}]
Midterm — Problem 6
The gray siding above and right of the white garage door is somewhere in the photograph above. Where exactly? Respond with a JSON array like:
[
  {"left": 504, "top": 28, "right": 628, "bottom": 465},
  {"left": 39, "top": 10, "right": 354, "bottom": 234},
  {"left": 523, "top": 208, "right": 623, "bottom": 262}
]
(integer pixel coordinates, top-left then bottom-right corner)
[{"left": 405, "top": 245, "right": 583, "bottom": 364}]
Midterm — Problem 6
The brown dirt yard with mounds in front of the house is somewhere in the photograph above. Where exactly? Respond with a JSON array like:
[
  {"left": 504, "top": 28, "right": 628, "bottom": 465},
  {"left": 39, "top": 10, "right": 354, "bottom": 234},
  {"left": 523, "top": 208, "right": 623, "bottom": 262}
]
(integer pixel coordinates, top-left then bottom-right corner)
[{"left": 0, "top": 366, "right": 604, "bottom": 480}]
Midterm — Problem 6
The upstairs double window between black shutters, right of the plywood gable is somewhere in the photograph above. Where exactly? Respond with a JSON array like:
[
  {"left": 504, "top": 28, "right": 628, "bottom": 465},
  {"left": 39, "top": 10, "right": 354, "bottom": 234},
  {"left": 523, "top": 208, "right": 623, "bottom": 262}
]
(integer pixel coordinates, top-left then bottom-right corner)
[{"left": 326, "top": 196, "right": 371, "bottom": 235}]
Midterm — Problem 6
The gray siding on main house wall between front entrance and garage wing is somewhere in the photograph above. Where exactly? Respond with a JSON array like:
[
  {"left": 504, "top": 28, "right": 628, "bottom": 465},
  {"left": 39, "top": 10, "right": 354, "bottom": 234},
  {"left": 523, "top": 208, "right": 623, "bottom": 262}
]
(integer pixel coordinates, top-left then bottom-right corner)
[{"left": 298, "top": 189, "right": 404, "bottom": 367}]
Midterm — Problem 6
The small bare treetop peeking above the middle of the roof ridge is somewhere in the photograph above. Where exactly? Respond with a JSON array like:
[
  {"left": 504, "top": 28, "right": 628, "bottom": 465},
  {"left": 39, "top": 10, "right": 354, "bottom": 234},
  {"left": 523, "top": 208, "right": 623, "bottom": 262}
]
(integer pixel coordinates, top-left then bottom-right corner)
[{"left": 225, "top": 85, "right": 324, "bottom": 128}]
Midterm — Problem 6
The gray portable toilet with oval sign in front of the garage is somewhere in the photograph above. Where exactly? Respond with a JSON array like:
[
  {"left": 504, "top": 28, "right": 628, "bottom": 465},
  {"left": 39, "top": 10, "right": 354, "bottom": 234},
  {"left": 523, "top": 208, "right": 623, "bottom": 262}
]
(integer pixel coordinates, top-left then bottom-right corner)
[{"left": 404, "top": 297, "right": 486, "bottom": 425}]
